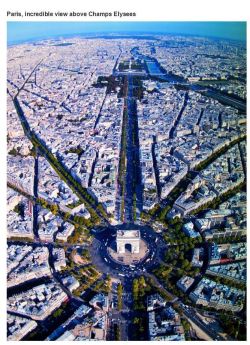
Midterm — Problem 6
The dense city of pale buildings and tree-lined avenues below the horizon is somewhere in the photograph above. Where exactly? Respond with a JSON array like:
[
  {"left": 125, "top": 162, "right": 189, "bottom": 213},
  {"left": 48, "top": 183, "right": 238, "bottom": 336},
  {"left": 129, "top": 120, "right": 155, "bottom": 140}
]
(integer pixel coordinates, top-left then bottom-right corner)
[{"left": 7, "top": 34, "right": 247, "bottom": 341}]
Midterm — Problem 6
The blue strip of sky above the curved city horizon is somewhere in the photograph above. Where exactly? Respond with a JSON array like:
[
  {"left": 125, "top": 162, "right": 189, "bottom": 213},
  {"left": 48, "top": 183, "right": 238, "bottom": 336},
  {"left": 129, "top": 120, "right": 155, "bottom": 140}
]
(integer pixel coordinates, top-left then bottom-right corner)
[{"left": 7, "top": 21, "right": 246, "bottom": 44}]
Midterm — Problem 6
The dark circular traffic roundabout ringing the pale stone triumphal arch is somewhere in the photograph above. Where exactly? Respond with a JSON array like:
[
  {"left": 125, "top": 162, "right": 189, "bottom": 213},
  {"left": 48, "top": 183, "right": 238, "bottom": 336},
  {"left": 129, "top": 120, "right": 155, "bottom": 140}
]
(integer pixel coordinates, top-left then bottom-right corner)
[{"left": 90, "top": 224, "right": 165, "bottom": 277}]
